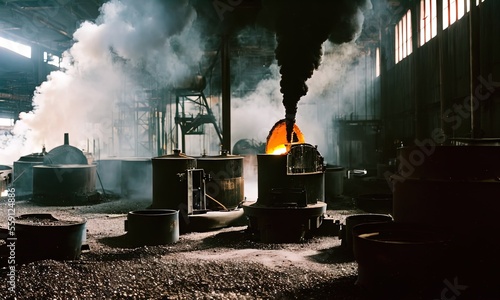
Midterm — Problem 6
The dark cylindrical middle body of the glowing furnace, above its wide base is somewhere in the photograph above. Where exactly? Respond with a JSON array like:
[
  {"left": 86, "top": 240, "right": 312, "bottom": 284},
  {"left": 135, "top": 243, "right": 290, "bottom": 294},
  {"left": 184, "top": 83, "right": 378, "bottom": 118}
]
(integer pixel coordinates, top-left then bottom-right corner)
[{"left": 257, "top": 154, "right": 325, "bottom": 206}]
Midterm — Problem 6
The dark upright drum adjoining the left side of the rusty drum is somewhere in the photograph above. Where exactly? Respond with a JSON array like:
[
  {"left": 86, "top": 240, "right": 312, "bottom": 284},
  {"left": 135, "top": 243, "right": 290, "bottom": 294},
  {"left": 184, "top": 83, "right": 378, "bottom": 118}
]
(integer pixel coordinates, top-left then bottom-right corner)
[{"left": 151, "top": 151, "right": 196, "bottom": 212}]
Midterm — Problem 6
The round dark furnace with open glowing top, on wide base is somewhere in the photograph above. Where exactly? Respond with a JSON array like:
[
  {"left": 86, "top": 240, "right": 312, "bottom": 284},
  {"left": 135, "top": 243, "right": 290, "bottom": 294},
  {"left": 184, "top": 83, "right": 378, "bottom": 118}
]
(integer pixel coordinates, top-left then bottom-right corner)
[{"left": 243, "top": 120, "right": 327, "bottom": 243}]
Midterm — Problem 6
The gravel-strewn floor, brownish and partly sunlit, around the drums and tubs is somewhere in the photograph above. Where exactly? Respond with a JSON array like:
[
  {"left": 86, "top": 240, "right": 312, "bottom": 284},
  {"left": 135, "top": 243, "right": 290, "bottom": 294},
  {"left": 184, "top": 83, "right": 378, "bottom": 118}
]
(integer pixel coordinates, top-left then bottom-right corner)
[{"left": 0, "top": 196, "right": 367, "bottom": 299}]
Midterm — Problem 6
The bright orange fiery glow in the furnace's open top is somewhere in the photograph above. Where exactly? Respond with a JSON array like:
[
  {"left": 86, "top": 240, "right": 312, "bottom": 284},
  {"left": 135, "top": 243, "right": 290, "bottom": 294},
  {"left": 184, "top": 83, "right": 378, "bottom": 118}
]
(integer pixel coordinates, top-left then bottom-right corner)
[{"left": 266, "top": 119, "right": 305, "bottom": 154}]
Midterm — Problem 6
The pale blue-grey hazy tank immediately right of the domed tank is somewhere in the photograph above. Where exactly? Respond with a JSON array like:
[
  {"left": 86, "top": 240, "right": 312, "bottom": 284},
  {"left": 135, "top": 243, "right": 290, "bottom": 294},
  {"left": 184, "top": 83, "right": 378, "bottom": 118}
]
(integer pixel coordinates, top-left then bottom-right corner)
[{"left": 96, "top": 158, "right": 122, "bottom": 195}]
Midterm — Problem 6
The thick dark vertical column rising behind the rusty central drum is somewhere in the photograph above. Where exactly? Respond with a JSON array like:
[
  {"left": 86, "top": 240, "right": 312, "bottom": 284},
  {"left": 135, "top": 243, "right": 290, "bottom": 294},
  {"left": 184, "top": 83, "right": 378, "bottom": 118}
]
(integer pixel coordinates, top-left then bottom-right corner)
[{"left": 221, "top": 35, "right": 231, "bottom": 153}]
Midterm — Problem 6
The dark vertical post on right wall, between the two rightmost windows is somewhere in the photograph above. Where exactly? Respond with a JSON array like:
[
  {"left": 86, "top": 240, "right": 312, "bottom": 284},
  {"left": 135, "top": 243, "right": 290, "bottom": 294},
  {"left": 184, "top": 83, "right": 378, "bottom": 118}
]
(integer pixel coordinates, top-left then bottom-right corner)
[{"left": 469, "top": 0, "right": 481, "bottom": 139}]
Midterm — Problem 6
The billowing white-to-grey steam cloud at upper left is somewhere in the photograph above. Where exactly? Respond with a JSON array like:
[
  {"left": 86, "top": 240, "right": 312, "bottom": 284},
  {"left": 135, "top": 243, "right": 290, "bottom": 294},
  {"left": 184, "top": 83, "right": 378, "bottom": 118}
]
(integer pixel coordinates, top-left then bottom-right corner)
[{"left": 0, "top": 0, "right": 202, "bottom": 164}]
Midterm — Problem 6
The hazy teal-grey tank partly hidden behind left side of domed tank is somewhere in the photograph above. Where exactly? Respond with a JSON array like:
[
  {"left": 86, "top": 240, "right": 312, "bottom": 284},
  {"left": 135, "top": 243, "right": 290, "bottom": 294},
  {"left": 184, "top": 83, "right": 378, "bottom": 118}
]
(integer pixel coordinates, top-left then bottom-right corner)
[{"left": 12, "top": 153, "right": 43, "bottom": 199}]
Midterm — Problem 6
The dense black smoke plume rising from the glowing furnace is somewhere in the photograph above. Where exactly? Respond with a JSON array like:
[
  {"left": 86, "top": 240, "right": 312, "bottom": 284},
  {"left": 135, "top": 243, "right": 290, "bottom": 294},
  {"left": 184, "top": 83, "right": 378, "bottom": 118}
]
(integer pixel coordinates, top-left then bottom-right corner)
[{"left": 263, "top": 0, "right": 371, "bottom": 141}]
